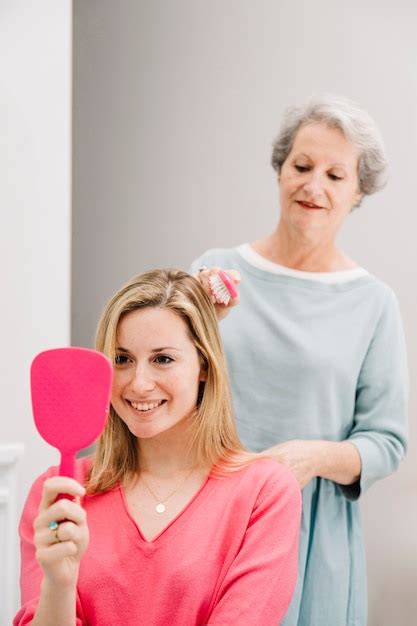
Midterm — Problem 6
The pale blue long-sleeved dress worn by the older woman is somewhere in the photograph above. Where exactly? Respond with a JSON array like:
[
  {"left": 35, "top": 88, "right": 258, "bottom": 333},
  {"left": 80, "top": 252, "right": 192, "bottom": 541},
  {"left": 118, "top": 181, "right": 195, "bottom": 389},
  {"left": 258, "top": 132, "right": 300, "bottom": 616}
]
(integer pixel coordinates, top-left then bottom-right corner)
[{"left": 191, "top": 246, "right": 408, "bottom": 626}]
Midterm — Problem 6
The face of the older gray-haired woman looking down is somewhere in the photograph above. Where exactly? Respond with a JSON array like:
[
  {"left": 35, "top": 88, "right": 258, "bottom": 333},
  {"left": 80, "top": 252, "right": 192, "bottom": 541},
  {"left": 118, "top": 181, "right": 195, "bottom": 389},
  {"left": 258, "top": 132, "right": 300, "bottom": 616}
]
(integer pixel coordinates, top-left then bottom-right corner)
[{"left": 279, "top": 122, "right": 361, "bottom": 237}]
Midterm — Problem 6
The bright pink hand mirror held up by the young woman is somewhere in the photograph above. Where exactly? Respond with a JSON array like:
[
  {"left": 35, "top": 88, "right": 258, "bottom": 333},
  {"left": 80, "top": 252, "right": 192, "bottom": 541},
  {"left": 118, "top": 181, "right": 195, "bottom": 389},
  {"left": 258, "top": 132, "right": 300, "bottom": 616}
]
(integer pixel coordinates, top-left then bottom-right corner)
[{"left": 30, "top": 348, "right": 113, "bottom": 477}]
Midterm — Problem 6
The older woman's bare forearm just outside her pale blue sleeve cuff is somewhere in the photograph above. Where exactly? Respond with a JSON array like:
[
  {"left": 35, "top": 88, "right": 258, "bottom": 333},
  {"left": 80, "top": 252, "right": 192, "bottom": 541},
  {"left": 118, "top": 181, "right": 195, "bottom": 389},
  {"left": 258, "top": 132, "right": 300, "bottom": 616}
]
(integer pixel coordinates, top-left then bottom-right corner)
[{"left": 315, "top": 441, "right": 361, "bottom": 485}]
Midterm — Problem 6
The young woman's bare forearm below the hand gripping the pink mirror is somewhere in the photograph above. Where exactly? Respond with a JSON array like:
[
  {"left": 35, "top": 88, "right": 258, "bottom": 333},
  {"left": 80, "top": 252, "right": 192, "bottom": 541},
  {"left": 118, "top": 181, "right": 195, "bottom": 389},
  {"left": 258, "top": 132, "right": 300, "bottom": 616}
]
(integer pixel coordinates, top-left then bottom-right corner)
[{"left": 32, "top": 579, "right": 77, "bottom": 626}]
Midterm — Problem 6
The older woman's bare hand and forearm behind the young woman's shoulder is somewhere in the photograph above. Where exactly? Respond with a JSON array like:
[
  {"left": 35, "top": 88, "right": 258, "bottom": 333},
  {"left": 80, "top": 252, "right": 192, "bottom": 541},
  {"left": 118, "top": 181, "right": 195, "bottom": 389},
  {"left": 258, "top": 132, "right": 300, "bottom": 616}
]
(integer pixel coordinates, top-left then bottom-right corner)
[{"left": 262, "top": 439, "right": 361, "bottom": 489}]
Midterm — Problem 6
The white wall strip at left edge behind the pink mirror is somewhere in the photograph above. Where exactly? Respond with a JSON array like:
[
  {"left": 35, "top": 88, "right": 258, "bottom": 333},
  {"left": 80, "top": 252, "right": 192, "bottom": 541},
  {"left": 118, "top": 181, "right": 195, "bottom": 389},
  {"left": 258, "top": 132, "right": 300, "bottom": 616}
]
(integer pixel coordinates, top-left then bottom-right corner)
[{"left": 0, "top": 0, "right": 72, "bottom": 624}]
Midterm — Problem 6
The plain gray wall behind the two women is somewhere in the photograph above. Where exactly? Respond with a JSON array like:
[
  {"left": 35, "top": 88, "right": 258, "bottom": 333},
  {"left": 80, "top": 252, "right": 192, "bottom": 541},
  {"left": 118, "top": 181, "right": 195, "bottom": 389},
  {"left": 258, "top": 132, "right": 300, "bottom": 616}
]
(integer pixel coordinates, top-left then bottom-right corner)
[{"left": 72, "top": 0, "right": 417, "bottom": 626}]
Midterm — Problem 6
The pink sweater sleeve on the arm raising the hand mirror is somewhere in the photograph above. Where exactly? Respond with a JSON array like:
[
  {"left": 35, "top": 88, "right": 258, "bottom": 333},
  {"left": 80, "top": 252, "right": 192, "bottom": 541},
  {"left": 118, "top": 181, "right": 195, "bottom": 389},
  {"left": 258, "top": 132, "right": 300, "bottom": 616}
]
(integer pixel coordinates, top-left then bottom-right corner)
[{"left": 13, "top": 468, "right": 87, "bottom": 626}]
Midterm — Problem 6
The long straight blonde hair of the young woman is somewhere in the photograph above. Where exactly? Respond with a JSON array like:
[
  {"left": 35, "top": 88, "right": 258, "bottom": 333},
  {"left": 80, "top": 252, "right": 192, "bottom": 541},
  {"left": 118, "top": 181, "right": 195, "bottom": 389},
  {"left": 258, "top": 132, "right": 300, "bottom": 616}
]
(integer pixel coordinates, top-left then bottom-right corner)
[{"left": 87, "top": 269, "right": 252, "bottom": 494}]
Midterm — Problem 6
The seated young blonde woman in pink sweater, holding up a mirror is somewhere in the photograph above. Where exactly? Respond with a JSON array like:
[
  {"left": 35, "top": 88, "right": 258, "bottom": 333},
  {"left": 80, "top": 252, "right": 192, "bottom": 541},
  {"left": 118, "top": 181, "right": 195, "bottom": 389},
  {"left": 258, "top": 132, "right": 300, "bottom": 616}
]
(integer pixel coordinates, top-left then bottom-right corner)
[{"left": 14, "top": 270, "right": 301, "bottom": 626}]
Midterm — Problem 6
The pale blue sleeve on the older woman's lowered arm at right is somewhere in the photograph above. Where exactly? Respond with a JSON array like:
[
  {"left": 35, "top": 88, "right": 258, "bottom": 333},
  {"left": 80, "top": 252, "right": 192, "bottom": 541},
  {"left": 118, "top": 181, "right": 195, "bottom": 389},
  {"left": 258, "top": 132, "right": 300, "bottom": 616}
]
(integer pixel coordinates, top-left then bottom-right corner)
[{"left": 339, "top": 290, "right": 408, "bottom": 500}]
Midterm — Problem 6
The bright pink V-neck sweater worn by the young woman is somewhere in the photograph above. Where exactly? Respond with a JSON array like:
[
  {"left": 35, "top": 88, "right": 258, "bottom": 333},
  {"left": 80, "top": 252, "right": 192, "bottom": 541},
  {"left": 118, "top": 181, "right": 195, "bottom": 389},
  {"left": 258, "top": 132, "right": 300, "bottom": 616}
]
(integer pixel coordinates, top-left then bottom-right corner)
[{"left": 13, "top": 459, "right": 301, "bottom": 626}]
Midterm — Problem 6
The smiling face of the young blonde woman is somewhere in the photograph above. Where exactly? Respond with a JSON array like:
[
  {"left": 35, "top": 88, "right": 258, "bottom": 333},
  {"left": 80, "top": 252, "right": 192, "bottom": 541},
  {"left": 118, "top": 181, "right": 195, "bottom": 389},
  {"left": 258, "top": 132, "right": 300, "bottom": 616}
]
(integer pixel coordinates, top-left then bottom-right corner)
[{"left": 112, "top": 307, "right": 206, "bottom": 438}]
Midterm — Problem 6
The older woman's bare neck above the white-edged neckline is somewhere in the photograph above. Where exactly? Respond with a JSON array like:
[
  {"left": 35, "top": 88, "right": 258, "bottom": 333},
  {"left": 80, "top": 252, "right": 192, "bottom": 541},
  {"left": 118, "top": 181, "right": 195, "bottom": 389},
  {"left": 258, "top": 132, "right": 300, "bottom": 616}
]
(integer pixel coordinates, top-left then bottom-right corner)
[{"left": 252, "top": 222, "right": 356, "bottom": 272}]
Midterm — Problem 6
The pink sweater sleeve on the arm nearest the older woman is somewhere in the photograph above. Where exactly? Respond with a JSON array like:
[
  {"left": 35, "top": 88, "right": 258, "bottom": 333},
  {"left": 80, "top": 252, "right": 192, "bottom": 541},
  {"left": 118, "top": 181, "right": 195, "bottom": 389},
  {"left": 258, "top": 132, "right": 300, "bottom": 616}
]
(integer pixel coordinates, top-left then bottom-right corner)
[{"left": 207, "top": 466, "right": 301, "bottom": 626}]
